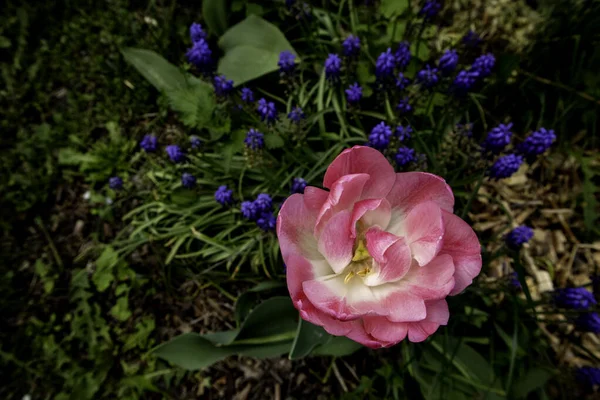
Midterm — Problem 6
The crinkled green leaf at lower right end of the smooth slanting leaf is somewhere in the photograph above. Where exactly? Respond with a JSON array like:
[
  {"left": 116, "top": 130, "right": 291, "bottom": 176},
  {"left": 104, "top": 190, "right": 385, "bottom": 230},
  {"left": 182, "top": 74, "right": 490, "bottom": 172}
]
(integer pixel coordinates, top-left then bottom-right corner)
[{"left": 166, "top": 79, "right": 216, "bottom": 129}]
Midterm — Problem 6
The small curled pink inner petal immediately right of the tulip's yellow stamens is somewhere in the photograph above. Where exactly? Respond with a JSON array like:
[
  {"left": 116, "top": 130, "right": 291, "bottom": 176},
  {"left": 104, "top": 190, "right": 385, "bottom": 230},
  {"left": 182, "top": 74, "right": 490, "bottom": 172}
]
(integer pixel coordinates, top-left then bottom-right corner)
[{"left": 364, "top": 227, "right": 412, "bottom": 286}]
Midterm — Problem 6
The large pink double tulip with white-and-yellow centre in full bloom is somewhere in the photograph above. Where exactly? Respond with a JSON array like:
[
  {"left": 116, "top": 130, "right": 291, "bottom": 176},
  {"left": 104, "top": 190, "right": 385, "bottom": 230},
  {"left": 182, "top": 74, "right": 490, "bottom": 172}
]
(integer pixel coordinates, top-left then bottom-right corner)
[{"left": 277, "top": 146, "right": 481, "bottom": 348}]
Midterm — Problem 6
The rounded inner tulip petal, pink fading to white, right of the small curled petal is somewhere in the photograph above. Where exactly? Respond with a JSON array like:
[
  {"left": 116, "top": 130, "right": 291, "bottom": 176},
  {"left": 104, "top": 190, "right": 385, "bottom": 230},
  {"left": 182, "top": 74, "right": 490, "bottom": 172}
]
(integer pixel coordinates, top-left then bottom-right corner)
[{"left": 396, "top": 201, "right": 444, "bottom": 266}]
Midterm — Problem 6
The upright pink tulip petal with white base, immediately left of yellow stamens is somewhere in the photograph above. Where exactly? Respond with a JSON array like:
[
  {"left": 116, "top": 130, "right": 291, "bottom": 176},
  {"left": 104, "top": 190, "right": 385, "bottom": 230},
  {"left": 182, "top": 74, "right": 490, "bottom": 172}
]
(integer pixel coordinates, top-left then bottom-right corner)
[{"left": 318, "top": 210, "right": 354, "bottom": 274}]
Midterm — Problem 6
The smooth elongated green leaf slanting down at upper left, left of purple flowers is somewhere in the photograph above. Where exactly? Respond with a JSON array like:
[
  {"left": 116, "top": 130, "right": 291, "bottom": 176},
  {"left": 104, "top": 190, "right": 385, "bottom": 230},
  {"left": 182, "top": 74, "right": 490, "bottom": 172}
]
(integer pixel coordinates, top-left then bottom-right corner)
[{"left": 121, "top": 47, "right": 187, "bottom": 92}]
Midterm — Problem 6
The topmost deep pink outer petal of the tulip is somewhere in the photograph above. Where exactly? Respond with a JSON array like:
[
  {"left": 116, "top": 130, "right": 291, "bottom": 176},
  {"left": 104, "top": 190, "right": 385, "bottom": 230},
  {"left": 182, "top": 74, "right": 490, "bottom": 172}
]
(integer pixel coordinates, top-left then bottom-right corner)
[{"left": 323, "top": 146, "right": 396, "bottom": 199}]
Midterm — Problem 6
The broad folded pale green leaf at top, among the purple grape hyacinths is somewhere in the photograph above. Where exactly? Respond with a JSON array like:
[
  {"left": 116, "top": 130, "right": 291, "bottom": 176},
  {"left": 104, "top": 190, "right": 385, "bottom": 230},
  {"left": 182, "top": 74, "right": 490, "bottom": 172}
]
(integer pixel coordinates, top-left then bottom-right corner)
[{"left": 218, "top": 15, "right": 300, "bottom": 86}]
